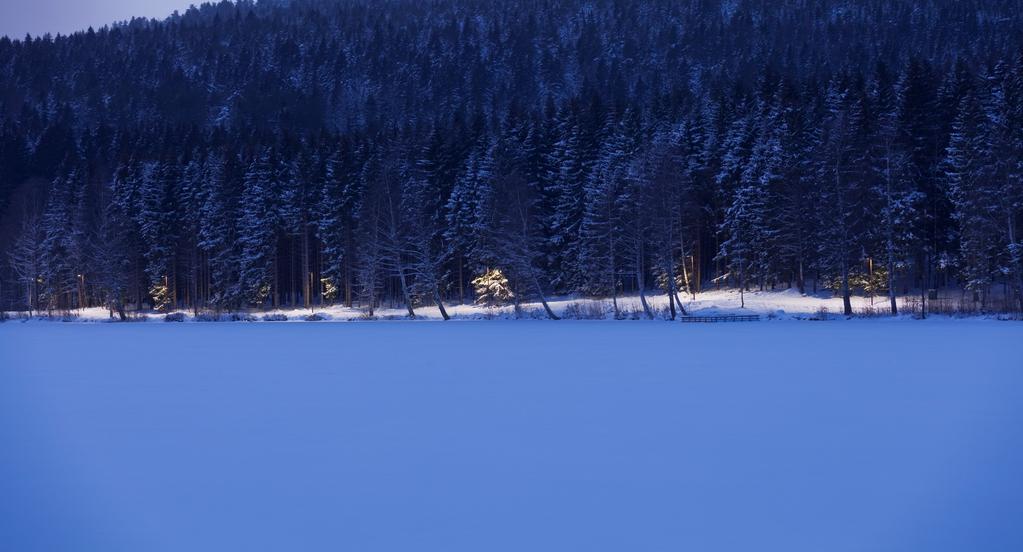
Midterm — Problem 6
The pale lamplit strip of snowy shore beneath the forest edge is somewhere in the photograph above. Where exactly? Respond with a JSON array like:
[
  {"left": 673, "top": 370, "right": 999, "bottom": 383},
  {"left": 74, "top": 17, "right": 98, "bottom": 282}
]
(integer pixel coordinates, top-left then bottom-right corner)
[{"left": 3, "top": 289, "right": 998, "bottom": 322}]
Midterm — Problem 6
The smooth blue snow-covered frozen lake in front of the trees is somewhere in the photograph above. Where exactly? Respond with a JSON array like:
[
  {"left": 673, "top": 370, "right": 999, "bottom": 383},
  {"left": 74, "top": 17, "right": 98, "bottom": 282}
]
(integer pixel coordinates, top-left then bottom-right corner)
[{"left": 0, "top": 320, "right": 1023, "bottom": 552}]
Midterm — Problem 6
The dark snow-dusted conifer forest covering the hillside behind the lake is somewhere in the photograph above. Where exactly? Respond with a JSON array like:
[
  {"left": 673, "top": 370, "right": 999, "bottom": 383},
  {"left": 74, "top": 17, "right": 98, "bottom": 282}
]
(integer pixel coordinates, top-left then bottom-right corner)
[{"left": 0, "top": 0, "right": 1023, "bottom": 312}]
